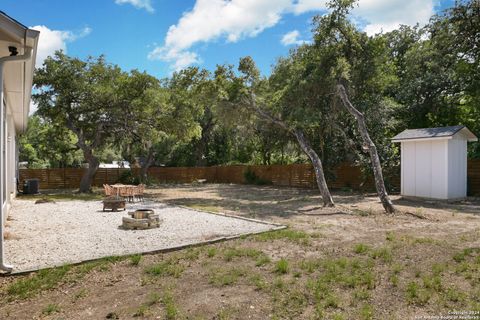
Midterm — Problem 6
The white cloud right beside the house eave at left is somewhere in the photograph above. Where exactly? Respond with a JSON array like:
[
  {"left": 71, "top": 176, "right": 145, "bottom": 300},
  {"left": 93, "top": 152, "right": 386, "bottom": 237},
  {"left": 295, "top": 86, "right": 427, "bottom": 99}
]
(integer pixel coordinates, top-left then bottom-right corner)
[{"left": 30, "top": 26, "right": 92, "bottom": 68}]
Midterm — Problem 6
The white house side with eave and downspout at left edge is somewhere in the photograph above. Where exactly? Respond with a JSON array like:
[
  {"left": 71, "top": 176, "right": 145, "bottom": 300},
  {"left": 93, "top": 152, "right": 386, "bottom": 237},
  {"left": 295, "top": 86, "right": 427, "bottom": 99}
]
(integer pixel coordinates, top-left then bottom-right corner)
[{"left": 0, "top": 11, "right": 39, "bottom": 271}]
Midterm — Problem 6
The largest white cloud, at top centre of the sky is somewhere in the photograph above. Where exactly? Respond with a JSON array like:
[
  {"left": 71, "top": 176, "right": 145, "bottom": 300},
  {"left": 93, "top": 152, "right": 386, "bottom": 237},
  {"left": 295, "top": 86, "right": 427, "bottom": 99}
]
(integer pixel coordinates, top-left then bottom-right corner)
[{"left": 148, "top": 0, "right": 291, "bottom": 69}]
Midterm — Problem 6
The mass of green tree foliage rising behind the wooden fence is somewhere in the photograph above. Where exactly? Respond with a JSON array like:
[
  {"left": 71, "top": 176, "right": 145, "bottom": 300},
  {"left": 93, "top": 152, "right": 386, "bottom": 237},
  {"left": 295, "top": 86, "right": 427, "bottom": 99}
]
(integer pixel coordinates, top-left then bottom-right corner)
[{"left": 20, "top": 0, "right": 480, "bottom": 196}]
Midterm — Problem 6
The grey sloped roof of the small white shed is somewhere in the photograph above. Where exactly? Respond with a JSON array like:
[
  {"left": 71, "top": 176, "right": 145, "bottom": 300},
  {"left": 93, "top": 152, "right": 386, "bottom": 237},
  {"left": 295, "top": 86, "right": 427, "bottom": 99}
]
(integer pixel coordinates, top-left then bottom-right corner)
[{"left": 392, "top": 126, "right": 477, "bottom": 142}]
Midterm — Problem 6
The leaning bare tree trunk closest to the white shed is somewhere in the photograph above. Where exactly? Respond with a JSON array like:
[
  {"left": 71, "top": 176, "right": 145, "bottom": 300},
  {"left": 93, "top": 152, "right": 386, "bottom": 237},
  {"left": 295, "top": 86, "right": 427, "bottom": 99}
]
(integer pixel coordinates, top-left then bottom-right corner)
[{"left": 337, "top": 84, "right": 395, "bottom": 213}]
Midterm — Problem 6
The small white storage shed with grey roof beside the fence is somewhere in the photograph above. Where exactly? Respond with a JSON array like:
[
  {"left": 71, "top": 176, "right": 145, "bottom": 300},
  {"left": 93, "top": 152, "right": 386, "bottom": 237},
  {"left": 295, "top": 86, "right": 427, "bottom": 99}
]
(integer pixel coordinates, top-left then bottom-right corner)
[{"left": 392, "top": 126, "right": 478, "bottom": 200}]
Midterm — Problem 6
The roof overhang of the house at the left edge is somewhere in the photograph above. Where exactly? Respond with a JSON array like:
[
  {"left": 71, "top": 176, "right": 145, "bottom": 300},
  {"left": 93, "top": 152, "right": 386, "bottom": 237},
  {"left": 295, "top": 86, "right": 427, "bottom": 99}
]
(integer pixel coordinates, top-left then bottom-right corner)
[{"left": 0, "top": 12, "right": 39, "bottom": 132}]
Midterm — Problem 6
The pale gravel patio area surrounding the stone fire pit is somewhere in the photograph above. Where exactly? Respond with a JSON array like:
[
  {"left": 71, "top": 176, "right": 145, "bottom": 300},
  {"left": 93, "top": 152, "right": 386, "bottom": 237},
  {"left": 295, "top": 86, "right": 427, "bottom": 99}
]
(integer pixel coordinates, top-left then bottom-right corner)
[{"left": 5, "top": 200, "right": 279, "bottom": 272}]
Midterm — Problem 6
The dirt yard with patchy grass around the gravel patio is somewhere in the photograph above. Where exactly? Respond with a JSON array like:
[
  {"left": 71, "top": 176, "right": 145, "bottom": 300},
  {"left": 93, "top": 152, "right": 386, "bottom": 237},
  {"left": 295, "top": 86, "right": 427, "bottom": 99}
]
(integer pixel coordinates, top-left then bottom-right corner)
[{"left": 0, "top": 184, "right": 480, "bottom": 320}]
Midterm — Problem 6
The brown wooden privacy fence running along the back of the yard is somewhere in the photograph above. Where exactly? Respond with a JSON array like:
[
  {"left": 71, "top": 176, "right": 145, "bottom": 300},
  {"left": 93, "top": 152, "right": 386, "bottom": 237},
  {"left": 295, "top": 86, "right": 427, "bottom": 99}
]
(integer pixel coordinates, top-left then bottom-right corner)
[{"left": 20, "top": 159, "right": 480, "bottom": 194}]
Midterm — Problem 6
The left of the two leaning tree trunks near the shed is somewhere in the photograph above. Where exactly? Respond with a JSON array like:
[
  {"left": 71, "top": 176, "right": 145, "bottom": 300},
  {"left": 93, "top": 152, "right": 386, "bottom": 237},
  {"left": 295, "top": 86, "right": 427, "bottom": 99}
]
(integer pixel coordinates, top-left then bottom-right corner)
[{"left": 292, "top": 129, "right": 335, "bottom": 207}]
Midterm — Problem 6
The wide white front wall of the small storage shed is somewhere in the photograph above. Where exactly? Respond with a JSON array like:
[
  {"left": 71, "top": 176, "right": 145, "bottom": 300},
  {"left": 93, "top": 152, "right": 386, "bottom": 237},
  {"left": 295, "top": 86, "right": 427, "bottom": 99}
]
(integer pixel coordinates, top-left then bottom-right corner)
[{"left": 401, "top": 140, "right": 448, "bottom": 199}]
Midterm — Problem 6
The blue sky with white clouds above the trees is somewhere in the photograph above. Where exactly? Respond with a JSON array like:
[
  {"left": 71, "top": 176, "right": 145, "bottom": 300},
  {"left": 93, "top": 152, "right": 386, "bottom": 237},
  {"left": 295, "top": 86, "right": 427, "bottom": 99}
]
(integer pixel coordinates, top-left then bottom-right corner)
[{"left": 0, "top": 0, "right": 454, "bottom": 77}]
